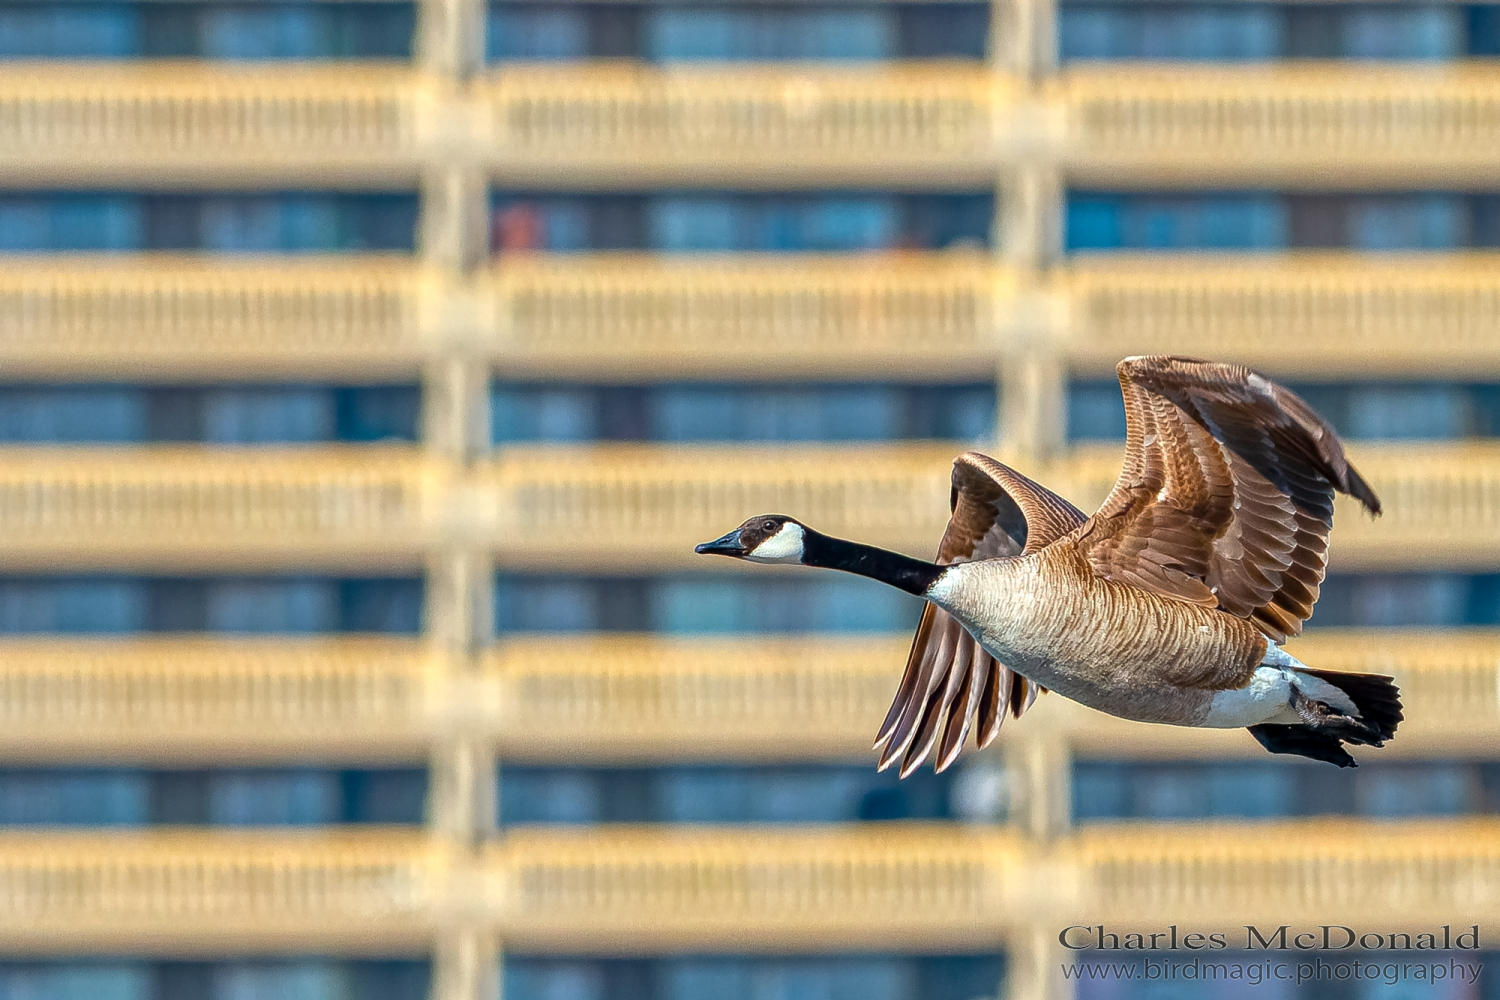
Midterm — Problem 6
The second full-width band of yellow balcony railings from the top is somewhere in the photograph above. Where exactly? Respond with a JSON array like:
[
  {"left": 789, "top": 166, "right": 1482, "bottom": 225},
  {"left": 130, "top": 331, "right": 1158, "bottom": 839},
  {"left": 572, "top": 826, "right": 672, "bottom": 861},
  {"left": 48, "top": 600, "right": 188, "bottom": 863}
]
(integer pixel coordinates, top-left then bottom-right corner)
[{"left": 0, "top": 252, "right": 1500, "bottom": 381}]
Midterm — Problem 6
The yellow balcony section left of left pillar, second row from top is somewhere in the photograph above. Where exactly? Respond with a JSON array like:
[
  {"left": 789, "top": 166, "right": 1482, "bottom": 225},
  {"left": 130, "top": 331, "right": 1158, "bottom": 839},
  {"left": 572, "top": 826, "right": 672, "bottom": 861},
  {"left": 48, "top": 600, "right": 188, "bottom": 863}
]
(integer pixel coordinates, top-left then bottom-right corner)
[{"left": 0, "top": 255, "right": 429, "bottom": 381}]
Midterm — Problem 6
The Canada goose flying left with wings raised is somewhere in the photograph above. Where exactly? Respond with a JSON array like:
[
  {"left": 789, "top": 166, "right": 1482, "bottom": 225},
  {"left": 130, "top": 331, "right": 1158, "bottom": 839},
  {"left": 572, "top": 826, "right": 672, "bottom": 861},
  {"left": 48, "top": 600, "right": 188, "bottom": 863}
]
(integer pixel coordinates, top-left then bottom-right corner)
[{"left": 698, "top": 355, "right": 1403, "bottom": 777}]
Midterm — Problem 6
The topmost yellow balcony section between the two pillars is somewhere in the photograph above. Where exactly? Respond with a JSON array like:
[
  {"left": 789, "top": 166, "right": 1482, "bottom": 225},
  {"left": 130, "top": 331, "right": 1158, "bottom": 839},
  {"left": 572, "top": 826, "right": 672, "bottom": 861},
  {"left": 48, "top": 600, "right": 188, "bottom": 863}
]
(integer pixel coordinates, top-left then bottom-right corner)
[{"left": 474, "top": 63, "right": 1020, "bottom": 187}]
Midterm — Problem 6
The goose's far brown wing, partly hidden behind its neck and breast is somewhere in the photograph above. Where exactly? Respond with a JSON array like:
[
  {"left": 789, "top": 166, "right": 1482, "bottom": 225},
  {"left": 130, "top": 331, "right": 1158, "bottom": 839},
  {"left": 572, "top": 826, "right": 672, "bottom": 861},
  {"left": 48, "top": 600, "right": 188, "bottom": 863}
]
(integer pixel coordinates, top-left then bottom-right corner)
[{"left": 875, "top": 451, "right": 1086, "bottom": 778}]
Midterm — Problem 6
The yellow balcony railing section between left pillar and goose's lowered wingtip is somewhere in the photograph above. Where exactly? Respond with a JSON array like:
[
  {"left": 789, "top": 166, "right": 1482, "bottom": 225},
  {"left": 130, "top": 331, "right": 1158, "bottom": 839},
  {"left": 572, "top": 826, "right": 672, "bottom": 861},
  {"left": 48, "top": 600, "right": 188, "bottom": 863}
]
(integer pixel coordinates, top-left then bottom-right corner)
[{"left": 486, "top": 636, "right": 911, "bottom": 760}]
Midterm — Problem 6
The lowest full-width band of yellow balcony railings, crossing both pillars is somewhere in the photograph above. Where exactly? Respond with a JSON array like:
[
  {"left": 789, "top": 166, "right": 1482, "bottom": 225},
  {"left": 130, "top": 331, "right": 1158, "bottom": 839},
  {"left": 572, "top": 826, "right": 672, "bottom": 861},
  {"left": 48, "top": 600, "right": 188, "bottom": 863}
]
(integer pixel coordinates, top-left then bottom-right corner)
[{"left": 0, "top": 820, "right": 1500, "bottom": 957}]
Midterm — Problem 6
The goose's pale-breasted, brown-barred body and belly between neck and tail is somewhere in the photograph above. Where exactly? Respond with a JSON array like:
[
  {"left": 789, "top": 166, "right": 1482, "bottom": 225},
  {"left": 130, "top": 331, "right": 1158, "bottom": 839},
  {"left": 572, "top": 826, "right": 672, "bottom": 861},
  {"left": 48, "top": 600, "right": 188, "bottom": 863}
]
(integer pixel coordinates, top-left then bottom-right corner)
[{"left": 936, "top": 567, "right": 1266, "bottom": 726}]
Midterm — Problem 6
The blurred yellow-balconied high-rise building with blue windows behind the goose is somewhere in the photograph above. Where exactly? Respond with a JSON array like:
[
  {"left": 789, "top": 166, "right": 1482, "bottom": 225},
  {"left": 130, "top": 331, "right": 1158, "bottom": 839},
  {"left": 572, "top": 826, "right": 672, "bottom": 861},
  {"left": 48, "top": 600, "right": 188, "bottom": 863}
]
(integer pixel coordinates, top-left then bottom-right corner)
[{"left": 0, "top": 0, "right": 1500, "bottom": 1000}]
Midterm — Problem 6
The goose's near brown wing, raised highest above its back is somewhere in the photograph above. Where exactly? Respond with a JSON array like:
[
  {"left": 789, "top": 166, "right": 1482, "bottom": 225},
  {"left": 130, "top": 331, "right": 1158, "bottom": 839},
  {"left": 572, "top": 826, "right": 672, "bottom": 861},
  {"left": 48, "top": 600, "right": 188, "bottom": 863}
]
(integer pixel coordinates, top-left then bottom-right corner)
[{"left": 1079, "top": 355, "right": 1380, "bottom": 642}]
